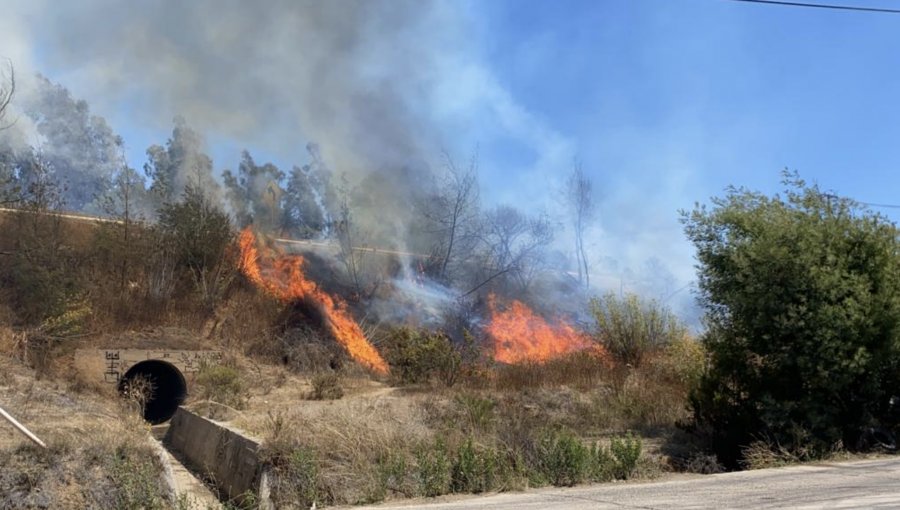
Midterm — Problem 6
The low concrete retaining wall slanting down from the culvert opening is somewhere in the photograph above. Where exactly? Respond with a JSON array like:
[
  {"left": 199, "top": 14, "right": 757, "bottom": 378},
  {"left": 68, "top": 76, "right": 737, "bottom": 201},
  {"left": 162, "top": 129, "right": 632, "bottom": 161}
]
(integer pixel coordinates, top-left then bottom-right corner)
[{"left": 164, "top": 407, "right": 261, "bottom": 501}]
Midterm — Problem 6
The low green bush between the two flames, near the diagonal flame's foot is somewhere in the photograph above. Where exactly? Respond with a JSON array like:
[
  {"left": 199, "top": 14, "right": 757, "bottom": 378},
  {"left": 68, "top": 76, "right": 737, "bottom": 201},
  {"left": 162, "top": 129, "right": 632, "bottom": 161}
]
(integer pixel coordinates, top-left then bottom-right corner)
[{"left": 382, "top": 327, "right": 463, "bottom": 387}]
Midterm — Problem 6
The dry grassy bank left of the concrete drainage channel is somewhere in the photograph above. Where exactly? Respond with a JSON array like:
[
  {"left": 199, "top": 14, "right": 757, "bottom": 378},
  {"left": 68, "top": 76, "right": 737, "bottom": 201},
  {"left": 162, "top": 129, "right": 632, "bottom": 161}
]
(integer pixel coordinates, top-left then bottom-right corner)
[{"left": 0, "top": 357, "right": 174, "bottom": 509}]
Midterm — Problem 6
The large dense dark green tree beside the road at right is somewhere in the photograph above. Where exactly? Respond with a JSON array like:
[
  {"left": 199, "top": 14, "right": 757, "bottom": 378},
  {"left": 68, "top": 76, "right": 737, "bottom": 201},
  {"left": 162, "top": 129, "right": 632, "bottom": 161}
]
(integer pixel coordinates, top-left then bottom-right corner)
[{"left": 682, "top": 174, "right": 900, "bottom": 465}]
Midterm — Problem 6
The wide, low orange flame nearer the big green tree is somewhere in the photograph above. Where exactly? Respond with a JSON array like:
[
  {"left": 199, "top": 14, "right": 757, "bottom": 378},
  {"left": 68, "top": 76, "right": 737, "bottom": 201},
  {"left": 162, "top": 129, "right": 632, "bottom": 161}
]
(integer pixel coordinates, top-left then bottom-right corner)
[{"left": 485, "top": 294, "right": 602, "bottom": 363}]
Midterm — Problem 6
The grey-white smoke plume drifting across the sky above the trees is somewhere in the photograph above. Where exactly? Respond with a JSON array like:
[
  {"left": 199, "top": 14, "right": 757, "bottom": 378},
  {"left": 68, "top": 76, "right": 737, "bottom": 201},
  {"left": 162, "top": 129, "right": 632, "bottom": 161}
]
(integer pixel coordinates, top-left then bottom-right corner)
[{"left": 0, "top": 0, "right": 704, "bottom": 324}]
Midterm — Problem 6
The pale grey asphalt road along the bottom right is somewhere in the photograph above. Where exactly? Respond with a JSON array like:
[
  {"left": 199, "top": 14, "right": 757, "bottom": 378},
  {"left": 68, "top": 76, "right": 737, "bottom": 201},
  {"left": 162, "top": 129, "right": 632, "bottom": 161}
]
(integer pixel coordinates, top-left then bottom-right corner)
[{"left": 366, "top": 458, "right": 900, "bottom": 510}]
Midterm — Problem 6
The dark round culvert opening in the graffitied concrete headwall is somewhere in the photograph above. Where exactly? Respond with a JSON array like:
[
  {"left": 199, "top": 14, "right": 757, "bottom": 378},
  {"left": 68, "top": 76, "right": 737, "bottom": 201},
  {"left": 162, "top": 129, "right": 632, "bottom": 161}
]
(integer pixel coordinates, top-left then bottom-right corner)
[{"left": 119, "top": 359, "right": 187, "bottom": 425}]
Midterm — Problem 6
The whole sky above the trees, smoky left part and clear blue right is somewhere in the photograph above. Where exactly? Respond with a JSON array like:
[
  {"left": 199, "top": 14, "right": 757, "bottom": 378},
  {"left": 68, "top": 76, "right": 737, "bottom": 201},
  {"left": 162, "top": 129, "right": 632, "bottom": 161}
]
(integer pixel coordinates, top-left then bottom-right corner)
[{"left": 0, "top": 0, "right": 900, "bottom": 308}]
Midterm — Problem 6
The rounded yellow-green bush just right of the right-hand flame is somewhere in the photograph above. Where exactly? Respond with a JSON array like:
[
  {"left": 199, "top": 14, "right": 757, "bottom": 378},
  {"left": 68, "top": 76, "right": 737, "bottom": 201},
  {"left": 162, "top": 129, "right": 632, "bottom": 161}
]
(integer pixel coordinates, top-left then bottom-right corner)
[{"left": 590, "top": 292, "right": 687, "bottom": 367}]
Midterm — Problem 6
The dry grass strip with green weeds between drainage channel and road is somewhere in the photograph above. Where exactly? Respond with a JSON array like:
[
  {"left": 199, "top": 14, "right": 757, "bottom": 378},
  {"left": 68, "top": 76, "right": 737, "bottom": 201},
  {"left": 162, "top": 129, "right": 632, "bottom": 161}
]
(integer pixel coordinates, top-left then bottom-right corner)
[{"left": 221, "top": 346, "right": 684, "bottom": 505}]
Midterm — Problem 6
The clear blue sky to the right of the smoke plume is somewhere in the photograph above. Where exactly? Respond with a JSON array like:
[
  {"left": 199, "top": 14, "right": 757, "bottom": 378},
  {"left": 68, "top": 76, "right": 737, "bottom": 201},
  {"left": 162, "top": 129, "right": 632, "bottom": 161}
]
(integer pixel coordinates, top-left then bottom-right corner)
[{"left": 472, "top": 0, "right": 900, "bottom": 203}]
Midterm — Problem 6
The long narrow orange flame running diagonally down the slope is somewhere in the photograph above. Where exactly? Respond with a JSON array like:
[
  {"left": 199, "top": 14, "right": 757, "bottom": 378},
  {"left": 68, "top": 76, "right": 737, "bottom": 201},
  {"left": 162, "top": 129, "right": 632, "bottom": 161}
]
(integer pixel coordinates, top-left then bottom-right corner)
[{"left": 239, "top": 227, "right": 388, "bottom": 374}]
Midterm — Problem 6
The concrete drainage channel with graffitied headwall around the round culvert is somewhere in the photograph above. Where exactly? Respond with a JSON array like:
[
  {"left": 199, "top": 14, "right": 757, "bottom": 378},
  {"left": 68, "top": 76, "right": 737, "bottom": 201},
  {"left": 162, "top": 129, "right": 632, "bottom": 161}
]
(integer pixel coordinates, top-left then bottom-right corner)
[{"left": 75, "top": 349, "right": 274, "bottom": 510}]
